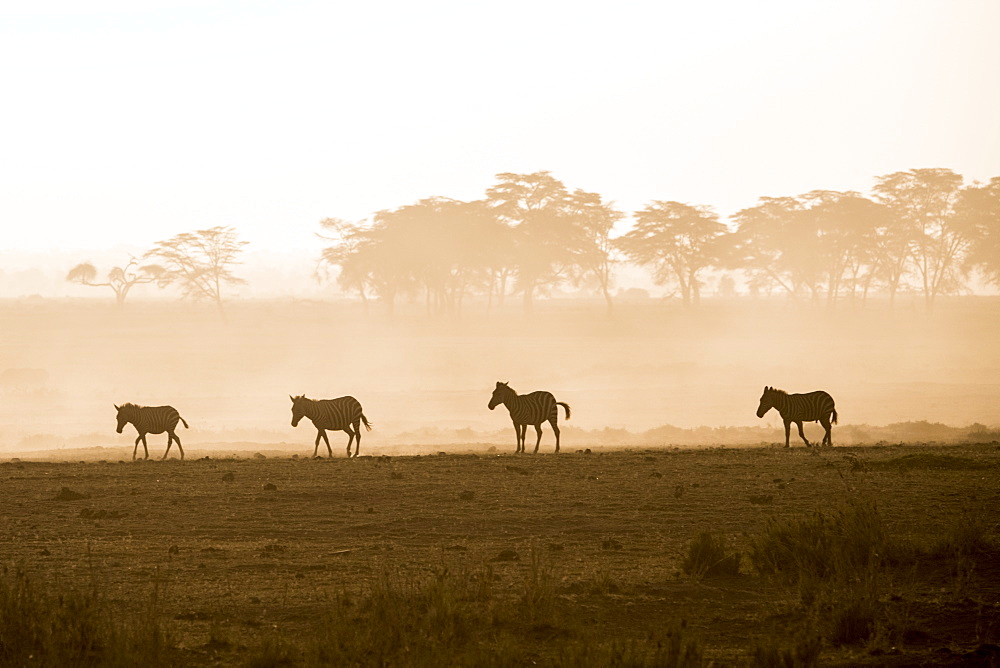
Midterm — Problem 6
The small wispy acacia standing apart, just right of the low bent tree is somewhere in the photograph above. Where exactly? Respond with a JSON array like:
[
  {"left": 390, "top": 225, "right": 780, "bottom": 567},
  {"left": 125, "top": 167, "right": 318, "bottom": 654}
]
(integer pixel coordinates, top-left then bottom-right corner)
[{"left": 144, "top": 226, "right": 247, "bottom": 317}]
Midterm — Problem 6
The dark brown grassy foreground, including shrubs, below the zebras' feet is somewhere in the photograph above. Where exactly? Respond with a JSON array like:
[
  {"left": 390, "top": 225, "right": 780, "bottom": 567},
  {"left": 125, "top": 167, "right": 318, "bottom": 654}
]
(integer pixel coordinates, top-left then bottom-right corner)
[{"left": 0, "top": 446, "right": 1000, "bottom": 666}]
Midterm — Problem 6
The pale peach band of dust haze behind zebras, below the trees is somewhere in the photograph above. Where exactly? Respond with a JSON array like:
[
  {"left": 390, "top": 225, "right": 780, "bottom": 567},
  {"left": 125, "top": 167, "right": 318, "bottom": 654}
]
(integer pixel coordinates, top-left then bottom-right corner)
[{"left": 0, "top": 293, "right": 1000, "bottom": 459}]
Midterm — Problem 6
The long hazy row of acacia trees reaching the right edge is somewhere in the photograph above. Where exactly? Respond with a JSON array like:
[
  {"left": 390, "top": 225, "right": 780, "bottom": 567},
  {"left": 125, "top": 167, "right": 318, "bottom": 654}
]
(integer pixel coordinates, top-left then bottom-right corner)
[{"left": 320, "top": 169, "right": 1000, "bottom": 312}]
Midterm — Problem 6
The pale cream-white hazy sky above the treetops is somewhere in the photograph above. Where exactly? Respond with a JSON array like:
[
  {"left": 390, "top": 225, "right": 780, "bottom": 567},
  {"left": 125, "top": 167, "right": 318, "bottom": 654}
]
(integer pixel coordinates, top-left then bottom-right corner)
[{"left": 0, "top": 0, "right": 1000, "bottom": 252}]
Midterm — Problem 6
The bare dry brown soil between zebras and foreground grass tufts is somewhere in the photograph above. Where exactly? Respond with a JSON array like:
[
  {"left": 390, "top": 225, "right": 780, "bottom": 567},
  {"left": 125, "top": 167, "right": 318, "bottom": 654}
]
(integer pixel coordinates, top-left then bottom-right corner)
[{"left": 0, "top": 444, "right": 1000, "bottom": 665}]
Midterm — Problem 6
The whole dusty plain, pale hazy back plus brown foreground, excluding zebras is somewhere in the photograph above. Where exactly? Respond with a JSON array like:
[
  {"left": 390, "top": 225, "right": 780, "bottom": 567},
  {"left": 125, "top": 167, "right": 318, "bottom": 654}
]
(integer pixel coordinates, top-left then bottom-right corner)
[{"left": 0, "top": 298, "right": 1000, "bottom": 666}]
